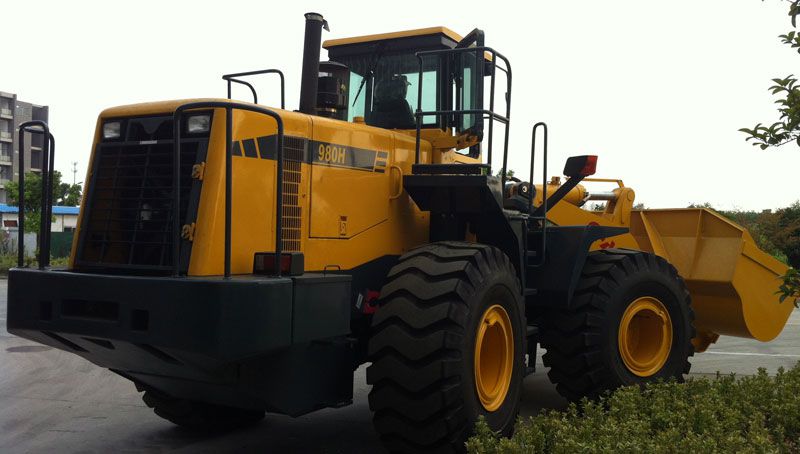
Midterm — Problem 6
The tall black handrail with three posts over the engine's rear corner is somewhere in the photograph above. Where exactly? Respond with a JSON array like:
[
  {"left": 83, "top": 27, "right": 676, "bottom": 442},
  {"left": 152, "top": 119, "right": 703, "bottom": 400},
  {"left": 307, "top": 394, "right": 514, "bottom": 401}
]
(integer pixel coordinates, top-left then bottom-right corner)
[{"left": 172, "top": 101, "right": 283, "bottom": 278}]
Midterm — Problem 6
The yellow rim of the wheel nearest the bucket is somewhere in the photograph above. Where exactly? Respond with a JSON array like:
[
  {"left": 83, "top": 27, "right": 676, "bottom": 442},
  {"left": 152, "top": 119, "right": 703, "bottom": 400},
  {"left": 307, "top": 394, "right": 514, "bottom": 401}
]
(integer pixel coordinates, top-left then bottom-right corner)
[{"left": 619, "top": 296, "right": 672, "bottom": 377}]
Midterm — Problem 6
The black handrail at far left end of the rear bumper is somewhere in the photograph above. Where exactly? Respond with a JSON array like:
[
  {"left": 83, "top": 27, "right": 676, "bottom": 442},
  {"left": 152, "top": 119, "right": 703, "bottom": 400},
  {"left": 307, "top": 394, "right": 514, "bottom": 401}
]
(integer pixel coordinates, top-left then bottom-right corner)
[{"left": 17, "top": 120, "right": 56, "bottom": 270}]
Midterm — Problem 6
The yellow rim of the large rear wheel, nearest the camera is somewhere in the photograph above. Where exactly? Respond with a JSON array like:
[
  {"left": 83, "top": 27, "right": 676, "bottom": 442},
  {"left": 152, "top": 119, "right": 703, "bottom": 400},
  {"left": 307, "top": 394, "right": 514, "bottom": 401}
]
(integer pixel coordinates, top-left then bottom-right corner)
[{"left": 475, "top": 304, "right": 514, "bottom": 411}]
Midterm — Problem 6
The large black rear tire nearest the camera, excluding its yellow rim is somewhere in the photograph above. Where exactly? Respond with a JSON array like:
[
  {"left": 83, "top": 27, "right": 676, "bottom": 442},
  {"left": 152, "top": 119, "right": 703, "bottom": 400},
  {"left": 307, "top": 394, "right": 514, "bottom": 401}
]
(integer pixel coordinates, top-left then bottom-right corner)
[{"left": 367, "top": 242, "right": 526, "bottom": 452}]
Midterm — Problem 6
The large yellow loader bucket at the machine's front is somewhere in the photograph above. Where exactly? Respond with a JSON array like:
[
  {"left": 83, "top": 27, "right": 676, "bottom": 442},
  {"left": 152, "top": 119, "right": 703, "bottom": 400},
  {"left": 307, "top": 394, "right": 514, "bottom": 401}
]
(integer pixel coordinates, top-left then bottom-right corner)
[{"left": 631, "top": 208, "right": 793, "bottom": 344}]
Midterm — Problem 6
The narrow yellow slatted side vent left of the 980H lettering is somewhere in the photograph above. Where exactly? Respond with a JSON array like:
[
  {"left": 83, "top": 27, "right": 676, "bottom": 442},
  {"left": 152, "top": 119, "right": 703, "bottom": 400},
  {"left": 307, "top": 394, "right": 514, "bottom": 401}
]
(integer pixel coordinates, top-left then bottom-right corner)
[{"left": 281, "top": 137, "right": 307, "bottom": 252}]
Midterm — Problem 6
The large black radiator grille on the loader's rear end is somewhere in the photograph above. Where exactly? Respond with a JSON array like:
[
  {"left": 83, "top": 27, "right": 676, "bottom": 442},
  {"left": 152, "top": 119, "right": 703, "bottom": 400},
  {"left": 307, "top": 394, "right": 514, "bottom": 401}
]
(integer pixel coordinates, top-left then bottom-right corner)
[{"left": 78, "top": 140, "right": 207, "bottom": 270}]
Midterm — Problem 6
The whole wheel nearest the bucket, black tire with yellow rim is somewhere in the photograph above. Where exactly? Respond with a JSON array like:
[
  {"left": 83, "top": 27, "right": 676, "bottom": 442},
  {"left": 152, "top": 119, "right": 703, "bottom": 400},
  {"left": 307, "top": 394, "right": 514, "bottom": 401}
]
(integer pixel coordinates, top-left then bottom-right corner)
[{"left": 541, "top": 249, "right": 695, "bottom": 401}]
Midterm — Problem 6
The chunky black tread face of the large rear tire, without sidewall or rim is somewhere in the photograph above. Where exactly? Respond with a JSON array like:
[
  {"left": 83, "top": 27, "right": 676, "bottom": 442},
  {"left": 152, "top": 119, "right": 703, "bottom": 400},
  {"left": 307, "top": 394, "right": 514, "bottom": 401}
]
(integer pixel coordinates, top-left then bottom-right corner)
[{"left": 367, "top": 242, "right": 524, "bottom": 452}]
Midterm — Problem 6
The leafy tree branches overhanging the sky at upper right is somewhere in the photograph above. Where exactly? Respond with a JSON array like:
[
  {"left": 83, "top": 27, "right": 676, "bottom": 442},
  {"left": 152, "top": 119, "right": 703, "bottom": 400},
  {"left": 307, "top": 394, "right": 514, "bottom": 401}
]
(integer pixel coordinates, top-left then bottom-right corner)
[{"left": 739, "top": 0, "right": 800, "bottom": 150}]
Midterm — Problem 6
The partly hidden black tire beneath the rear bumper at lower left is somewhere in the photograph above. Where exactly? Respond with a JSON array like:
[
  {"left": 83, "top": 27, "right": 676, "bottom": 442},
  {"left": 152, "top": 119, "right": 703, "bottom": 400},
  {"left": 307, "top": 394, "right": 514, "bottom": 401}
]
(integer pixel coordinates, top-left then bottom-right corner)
[{"left": 142, "top": 390, "right": 265, "bottom": 432}]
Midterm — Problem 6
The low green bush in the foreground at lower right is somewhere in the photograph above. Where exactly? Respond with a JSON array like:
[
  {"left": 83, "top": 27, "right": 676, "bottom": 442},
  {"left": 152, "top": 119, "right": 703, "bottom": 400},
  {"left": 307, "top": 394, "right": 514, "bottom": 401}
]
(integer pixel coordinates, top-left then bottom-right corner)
[{"left": 467, "top": 364, "right": 800, "bottom": 453}]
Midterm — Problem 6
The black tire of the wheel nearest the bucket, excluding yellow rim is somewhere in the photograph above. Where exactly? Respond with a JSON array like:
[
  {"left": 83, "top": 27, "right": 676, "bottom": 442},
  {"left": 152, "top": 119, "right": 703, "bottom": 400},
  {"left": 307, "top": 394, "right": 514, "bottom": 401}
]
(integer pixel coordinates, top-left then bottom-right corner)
[{"left": 541, "top": 249, "right": 695, "bottom": 401}]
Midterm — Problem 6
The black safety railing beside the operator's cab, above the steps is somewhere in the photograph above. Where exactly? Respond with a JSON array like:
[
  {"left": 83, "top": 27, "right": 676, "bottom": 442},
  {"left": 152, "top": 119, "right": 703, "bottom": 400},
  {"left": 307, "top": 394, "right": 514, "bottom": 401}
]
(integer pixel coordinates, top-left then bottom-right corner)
[{"left": 414, "top": 46, "right": 511, "bottom": 186}]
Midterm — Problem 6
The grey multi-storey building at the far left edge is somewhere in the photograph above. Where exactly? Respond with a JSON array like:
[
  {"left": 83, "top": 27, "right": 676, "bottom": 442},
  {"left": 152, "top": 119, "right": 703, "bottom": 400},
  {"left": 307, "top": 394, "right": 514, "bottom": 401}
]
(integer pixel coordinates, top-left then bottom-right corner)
[{"left": 0, "top": 91, "right": 49, "bottom": 203}]
